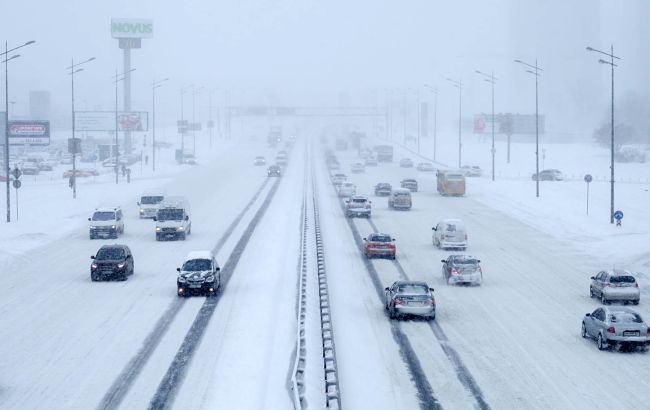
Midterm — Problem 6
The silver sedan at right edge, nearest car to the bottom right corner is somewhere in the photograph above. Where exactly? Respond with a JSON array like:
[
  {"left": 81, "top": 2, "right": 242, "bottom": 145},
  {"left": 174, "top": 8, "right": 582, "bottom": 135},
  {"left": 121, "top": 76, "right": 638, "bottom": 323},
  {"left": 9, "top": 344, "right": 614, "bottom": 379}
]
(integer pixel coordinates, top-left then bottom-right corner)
[{"left": 581, "top": 306, "right": 650, "bottom": 350}]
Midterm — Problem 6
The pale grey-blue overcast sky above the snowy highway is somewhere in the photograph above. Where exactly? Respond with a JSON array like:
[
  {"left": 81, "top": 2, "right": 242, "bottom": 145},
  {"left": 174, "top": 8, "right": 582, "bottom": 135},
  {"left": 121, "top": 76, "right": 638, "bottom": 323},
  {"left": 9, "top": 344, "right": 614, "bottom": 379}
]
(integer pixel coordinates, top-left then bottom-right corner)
[{"left": 0, "top": 0, "right": 650, "bottom": 132}]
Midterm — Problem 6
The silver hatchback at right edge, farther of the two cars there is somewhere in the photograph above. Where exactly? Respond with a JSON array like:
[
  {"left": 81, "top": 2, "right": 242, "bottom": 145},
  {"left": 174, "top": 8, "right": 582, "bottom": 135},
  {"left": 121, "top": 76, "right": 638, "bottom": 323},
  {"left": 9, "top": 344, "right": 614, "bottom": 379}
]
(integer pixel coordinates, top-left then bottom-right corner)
[{"left": 589, "top": 269, "right": 641, "bottom": 305}]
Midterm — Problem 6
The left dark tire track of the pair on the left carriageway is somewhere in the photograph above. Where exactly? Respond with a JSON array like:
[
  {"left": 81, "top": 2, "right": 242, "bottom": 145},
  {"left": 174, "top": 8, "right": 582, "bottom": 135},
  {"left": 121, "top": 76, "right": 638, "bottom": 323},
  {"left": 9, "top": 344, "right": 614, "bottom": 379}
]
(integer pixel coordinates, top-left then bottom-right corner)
[{"left": 97, "top": 179, "right": 268, "bottom": 410}]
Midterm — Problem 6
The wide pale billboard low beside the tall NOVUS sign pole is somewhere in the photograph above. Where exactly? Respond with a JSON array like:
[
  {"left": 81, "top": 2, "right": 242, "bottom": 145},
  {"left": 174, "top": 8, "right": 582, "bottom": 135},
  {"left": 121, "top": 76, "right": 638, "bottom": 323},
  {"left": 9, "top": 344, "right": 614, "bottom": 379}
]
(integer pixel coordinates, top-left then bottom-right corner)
[{"left": 74, "top": 111, "right": 149, "bottom": 131}]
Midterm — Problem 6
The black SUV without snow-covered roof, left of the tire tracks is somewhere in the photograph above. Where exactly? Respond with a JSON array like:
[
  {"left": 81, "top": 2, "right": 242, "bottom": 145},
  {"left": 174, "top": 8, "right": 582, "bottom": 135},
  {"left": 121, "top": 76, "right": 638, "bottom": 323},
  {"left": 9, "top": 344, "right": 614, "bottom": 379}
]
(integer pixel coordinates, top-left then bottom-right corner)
[{"left": 90, "top": 244, "right": 135, "bottom": 282}]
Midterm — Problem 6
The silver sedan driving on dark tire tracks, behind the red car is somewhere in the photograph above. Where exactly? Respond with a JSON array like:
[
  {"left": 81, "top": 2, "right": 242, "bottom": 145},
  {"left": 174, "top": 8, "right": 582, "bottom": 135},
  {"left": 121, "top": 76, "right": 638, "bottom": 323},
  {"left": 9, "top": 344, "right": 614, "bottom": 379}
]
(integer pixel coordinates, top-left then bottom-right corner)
[{"left": 384, "top": 280, "right": 436, "bottom": 320}]
